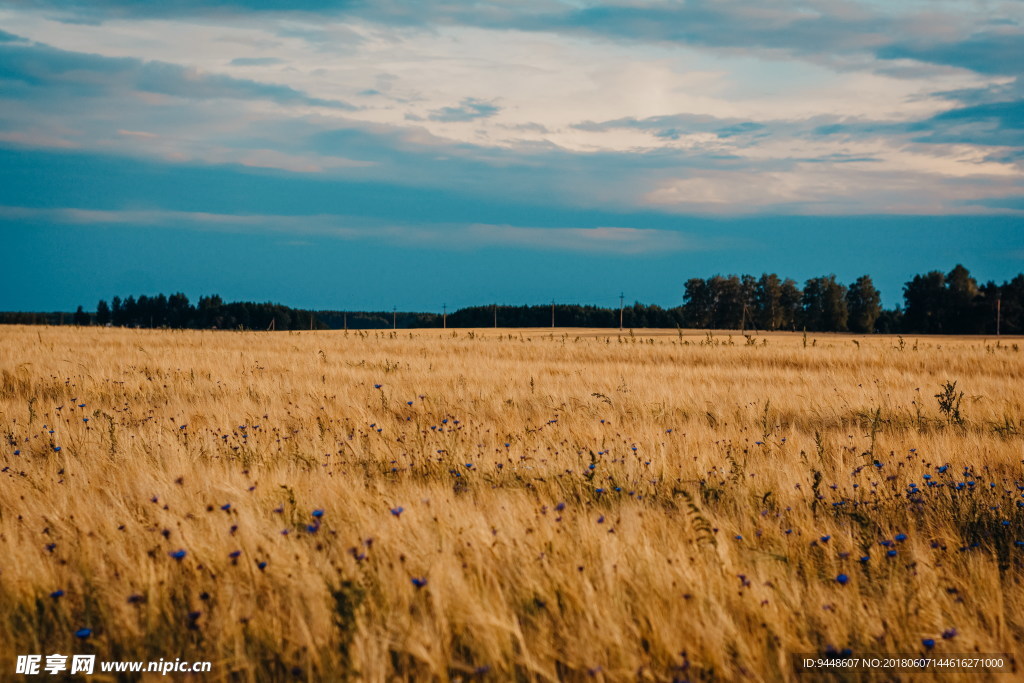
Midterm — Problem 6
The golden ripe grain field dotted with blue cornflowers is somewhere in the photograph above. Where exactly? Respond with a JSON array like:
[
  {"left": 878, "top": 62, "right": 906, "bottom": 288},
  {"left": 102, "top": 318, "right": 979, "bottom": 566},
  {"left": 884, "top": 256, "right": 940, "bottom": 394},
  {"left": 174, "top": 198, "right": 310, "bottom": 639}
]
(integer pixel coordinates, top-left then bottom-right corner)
[{"left": 0, "top": 327, "right": 1024, "bottom": 681}]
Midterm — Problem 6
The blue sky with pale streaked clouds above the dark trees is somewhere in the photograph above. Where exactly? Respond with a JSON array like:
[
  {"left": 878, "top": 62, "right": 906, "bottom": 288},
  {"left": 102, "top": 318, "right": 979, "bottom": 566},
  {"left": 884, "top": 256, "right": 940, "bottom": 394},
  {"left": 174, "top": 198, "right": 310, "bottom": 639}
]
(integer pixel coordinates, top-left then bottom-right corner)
[{"left": 0, "top": 0, "right": 1024, "bottom": 311}]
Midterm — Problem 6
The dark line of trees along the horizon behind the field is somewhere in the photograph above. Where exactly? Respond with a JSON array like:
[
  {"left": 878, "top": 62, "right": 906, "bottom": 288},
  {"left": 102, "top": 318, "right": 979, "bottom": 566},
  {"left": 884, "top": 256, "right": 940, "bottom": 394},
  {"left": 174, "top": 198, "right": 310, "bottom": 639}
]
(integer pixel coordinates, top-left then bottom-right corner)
[{"left": 0, "top": 265, "right": 1024, "bottom": 334}]
